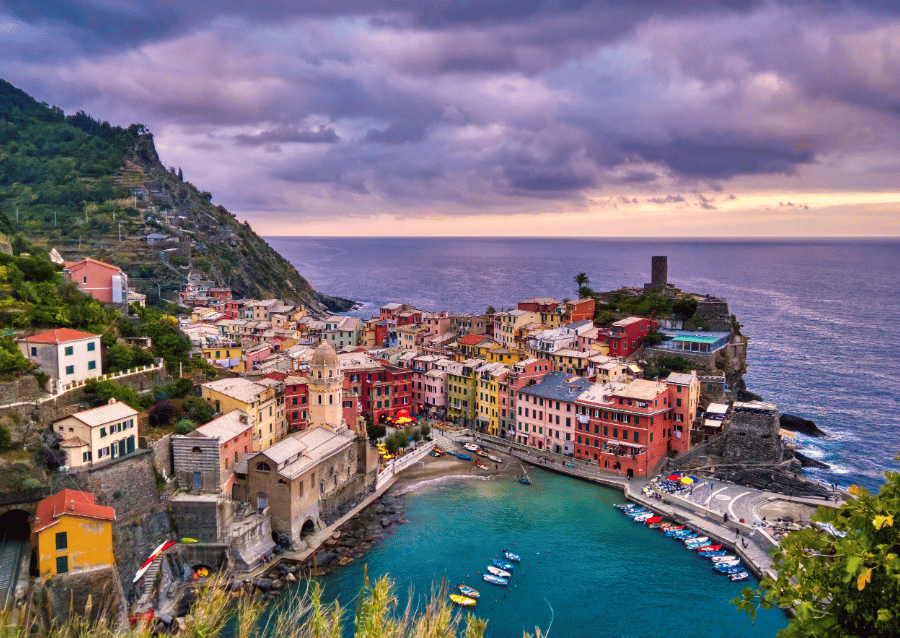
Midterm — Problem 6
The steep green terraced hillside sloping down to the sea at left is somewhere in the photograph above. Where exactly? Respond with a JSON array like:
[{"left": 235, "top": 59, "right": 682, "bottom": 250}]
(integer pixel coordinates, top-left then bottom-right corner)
[{"left": 0, "top": 80, "right": 351, "bottom": 314}]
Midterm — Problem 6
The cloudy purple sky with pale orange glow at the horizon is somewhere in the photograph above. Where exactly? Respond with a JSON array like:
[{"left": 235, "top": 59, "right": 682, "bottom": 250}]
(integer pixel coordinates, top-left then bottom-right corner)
[{"left": 0, "top": 0, "right": 900, "bottom": 237}]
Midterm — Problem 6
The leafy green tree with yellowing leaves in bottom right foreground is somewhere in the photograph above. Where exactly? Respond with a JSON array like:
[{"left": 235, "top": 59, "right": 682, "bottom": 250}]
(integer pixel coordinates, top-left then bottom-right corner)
[{"left": 732, "top": 457, "right": 900, "bottom": 638}]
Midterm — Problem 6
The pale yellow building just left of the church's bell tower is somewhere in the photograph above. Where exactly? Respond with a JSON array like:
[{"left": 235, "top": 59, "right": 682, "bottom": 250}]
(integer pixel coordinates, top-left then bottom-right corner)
[{"left": 200, "top": 377, "right": 287, "bottom": 452}]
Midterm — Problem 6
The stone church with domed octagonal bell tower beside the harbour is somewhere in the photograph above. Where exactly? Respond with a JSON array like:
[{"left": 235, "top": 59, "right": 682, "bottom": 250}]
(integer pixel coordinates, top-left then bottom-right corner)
[{"left": 234, "top": 342, "right": 378, "bottom": 549}]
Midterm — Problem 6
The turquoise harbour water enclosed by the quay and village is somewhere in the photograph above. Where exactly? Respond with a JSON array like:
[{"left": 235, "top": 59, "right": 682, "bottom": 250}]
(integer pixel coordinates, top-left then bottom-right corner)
[{"left": 310, "top": 469, "right": 787, "bottom": 638}]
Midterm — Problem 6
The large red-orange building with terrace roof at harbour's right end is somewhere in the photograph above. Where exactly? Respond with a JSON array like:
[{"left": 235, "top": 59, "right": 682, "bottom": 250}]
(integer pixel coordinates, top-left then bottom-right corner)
[{"left": 575, "top": 379, "right": 675, "bottom": 477}]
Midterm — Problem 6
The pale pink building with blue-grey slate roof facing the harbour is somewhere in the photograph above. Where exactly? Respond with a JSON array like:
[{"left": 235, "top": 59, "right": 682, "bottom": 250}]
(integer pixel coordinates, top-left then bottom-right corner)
[{"left": 515, "top": 372, "right": 593, "bottom": 455}]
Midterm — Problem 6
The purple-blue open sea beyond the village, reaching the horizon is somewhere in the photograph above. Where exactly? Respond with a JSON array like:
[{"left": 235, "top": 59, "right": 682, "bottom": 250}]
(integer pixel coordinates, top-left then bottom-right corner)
[{"left": 267, "top": 237, "right": 900, "bottom": 490}]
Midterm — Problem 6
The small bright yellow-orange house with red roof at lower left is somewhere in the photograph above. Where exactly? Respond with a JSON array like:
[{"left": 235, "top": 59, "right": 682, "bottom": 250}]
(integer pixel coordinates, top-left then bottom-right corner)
[{"left": 31, "top": 490, "right": 116, "bottom": 580}]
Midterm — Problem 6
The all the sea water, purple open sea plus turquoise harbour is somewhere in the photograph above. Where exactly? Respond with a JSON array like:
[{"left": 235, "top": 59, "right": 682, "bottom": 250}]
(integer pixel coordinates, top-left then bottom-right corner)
[{"left": 256, "top": 237, "right": 900, "bottom": 638}]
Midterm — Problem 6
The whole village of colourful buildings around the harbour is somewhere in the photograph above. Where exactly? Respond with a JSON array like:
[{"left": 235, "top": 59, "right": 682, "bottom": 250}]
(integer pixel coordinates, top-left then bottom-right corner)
[{"left": 3, "top": 254, "right": 800, "bottom": 632}]
